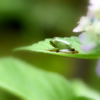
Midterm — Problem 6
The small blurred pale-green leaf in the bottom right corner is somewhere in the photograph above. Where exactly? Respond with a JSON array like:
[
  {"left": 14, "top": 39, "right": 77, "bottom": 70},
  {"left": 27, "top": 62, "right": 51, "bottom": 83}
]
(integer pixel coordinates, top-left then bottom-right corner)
[{"left": 72, "top": 80, "right": 100, "bottom": 100}]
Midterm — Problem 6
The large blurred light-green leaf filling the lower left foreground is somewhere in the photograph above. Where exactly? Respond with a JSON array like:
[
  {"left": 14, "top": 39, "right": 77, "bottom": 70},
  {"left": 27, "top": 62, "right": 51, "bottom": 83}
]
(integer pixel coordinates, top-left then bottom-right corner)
[{"left": 0, "top": 58, "right": 74, "bottom": 100}]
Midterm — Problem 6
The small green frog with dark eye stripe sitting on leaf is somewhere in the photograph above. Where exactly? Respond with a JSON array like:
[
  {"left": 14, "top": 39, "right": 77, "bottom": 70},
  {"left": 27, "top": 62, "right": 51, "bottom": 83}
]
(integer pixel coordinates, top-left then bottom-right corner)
[{"left": 50, "top": 38, "right": 78, "bottom": 54}]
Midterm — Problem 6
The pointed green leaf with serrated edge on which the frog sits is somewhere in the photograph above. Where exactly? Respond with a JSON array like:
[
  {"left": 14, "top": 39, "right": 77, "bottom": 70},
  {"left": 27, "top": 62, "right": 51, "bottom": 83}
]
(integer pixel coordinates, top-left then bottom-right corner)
[{"left": 14, "top": 37, "right": 100, "bottom": 59}]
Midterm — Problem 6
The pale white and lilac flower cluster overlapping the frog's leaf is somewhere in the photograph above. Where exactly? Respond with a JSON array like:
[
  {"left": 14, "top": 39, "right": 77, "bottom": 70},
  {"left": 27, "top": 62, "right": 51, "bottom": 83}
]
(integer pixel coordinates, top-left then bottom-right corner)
[{"left": 73, "top": 0, "right": 100, "bottom": 51}]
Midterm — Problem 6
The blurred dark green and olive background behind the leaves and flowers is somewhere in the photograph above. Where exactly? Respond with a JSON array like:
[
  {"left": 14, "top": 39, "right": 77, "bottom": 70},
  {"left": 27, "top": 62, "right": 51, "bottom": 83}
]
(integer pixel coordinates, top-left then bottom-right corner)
[{"left": 0, "top": 0, "right": 100, "bottom": 96}]
